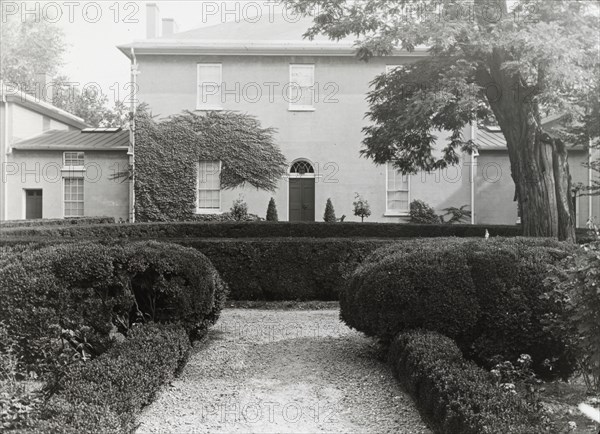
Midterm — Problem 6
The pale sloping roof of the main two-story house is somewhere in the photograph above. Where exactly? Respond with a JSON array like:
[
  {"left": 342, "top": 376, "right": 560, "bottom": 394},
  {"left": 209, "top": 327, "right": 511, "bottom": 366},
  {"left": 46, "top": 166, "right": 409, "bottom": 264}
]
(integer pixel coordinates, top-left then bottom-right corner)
[{"left": 117, "top": 11, "right": 426, "bottom": 57}]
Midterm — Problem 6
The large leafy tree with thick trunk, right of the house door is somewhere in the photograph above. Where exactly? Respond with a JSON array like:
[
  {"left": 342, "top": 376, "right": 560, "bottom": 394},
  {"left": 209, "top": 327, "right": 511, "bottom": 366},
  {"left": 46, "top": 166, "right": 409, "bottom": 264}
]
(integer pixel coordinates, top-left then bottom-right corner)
[{"left": 288, "top": 0, "right": 599, "bottom": 240}]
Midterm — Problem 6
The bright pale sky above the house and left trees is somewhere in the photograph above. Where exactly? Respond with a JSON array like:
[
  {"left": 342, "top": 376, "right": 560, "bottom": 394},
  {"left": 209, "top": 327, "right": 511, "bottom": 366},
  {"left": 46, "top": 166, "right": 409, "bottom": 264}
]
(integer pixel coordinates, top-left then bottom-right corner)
[{"left": 1, "top": 0, "right": 279, "bottom": 105}]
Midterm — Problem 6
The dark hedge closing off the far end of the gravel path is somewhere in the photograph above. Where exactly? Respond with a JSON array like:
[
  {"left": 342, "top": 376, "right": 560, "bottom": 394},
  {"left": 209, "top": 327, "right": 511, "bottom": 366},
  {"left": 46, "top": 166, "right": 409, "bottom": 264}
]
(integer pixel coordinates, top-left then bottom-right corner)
[{"left": 179, "top": 238, "right": 390, "bottom": 301}]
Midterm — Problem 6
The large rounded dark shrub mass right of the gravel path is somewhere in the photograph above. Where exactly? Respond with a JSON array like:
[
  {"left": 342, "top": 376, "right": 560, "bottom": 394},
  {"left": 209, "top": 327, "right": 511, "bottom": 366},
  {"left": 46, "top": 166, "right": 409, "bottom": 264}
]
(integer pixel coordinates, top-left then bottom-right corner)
[{"left": 340, "top": 238, "right": 575, "bottom": 378}]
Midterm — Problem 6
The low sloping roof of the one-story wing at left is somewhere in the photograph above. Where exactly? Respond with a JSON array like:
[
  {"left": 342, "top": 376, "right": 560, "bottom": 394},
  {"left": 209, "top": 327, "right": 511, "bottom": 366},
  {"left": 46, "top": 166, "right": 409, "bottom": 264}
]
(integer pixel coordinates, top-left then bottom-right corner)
[{"left": 12, "top": 129, "right": 129, "bottom": 151}]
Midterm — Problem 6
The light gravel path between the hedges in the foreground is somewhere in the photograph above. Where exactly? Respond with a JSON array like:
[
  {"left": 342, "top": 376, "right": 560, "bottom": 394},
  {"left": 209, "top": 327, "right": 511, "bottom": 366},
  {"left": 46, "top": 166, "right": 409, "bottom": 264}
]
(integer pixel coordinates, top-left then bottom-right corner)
[{"left": 137, "top": 309, "right": 431, "bottom": 433}]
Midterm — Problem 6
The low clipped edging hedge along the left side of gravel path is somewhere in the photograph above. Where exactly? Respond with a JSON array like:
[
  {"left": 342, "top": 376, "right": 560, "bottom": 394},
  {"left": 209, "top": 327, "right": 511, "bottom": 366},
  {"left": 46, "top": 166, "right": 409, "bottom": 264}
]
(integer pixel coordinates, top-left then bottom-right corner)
[{"left": 28, "top": 324, "right": 191, "bottom": 434}]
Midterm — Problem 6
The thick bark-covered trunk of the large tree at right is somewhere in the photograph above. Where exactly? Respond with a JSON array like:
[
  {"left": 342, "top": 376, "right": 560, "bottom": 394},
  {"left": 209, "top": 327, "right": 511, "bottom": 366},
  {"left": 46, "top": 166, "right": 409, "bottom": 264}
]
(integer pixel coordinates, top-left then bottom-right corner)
[{"left": 478, "top": 50, "right": 575, "bottom": 242}]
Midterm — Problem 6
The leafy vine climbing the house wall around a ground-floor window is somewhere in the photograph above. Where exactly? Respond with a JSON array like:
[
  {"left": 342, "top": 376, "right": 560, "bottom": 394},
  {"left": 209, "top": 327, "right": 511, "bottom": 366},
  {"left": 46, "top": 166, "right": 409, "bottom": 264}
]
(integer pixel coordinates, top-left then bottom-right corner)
[{"left": 135, "top": 106, "right": 287, "bottom": 221}]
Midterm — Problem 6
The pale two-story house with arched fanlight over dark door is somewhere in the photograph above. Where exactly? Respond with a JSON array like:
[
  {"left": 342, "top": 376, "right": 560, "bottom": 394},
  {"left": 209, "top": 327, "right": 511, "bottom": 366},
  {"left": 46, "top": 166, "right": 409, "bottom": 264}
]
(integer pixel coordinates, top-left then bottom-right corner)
[{"left": 118, "top": 3, "right": 598, "bottom": 224}]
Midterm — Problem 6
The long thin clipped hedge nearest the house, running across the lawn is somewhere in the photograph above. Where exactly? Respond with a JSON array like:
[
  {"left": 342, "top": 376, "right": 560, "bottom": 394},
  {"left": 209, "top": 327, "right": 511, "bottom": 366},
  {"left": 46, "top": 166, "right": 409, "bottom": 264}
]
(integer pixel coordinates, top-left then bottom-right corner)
[{"left": 2, "top": 222, "right": 521, "bottom": 239}]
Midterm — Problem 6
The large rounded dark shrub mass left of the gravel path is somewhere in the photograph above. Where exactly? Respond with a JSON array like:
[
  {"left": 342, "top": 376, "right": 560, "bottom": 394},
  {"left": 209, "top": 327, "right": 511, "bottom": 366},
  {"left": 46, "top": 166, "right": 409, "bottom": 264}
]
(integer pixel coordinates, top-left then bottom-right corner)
[{"left": 0, "top": 242, "right": 226, "bottom": 376}]
